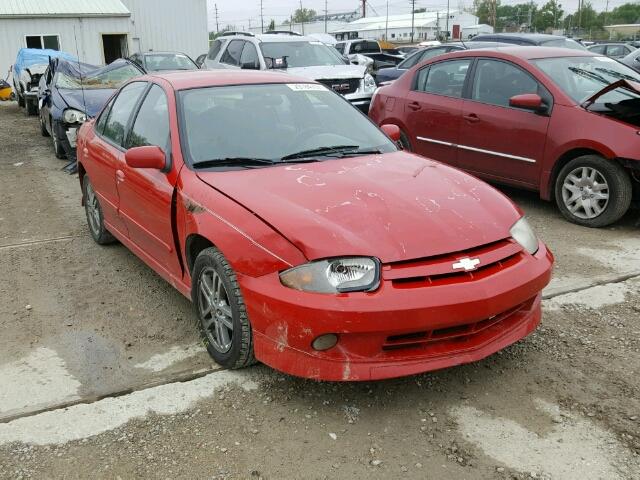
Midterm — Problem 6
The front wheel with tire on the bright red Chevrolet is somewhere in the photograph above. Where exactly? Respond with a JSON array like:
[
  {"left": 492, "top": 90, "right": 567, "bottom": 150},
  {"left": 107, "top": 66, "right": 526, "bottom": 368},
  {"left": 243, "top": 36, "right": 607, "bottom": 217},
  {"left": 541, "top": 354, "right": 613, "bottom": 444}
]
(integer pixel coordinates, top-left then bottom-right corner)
[{"left": 191, "top": 247, "right": 256, "bottom": 369}]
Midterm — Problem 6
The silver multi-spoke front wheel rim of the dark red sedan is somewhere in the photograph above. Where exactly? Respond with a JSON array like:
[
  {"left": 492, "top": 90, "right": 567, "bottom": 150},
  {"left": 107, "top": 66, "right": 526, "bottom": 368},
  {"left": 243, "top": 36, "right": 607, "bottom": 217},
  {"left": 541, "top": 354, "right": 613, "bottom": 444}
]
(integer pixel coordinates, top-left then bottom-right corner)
[{"left": 562, "top": 167, "right": 609, "bottom": 220}]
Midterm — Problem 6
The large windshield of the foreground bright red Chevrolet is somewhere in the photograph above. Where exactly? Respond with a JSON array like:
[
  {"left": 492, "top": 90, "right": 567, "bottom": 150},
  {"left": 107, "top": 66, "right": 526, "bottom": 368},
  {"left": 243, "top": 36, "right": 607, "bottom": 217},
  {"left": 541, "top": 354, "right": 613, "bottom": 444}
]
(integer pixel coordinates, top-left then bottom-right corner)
[{"left": 179, "top": 84, "right": 396, "bottom": 164}]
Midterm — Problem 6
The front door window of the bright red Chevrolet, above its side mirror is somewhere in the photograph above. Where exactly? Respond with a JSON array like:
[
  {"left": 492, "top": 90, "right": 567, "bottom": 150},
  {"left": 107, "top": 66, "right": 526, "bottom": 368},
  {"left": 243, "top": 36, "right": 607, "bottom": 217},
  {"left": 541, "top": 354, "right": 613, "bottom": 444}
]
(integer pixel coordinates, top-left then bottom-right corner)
[{"left": 127, "top": 85, "right": 169, "bottom": 149}]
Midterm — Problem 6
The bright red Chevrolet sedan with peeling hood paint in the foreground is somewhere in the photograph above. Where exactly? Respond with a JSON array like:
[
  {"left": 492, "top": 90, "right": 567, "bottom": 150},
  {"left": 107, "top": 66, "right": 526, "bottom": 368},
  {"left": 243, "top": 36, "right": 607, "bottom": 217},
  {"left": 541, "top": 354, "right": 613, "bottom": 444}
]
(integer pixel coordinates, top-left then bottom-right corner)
[{"left": 78, "top": 71, "right": 553, "bottom": 380}]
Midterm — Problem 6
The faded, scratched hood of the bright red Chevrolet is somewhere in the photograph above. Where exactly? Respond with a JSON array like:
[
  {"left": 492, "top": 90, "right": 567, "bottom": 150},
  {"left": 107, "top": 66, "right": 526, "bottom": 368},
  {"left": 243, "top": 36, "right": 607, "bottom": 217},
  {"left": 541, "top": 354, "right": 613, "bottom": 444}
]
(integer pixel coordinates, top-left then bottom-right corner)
[{"left": 198, "top": 152, "right": 520, "bottom": 262}]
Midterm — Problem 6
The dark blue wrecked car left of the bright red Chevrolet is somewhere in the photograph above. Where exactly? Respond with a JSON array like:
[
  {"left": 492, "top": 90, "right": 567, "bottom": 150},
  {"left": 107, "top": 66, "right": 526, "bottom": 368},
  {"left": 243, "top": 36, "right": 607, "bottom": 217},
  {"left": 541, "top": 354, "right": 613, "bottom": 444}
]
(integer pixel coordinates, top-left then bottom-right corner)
[{"left": 38, "top": 58, "right": 144, "bottom": 166}]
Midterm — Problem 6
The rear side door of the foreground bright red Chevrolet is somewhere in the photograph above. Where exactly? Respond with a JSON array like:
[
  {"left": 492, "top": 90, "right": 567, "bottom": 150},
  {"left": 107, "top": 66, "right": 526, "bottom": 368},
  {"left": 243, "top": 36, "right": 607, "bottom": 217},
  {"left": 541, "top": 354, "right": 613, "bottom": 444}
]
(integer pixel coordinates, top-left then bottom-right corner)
[{"left": 83, "top": 82, "right": 147, "bottom": 237}]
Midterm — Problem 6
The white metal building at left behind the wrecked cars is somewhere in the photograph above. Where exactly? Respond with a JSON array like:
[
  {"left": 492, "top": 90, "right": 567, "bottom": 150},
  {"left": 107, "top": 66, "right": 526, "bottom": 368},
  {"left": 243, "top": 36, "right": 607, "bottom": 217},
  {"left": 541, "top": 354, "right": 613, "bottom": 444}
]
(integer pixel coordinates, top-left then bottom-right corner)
[{"left": 0, "top": 0, "right": 209, "bottom": 74}]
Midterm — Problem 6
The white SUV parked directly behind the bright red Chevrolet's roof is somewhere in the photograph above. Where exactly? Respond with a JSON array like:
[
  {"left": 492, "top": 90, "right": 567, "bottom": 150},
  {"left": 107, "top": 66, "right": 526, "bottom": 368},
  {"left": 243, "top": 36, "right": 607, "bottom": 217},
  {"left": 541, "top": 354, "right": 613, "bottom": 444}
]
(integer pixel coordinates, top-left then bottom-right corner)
[{"left": 202, "top": 32, "right": 376, "bottom": 113}]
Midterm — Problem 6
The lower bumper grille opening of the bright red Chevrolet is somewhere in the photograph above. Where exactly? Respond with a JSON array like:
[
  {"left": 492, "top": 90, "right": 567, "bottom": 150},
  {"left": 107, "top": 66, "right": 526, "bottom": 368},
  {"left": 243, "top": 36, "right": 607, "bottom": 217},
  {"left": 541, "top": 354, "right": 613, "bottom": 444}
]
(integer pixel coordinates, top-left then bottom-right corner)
[{"left": 382, "top": 299, "right": 533, "bottom": 351}]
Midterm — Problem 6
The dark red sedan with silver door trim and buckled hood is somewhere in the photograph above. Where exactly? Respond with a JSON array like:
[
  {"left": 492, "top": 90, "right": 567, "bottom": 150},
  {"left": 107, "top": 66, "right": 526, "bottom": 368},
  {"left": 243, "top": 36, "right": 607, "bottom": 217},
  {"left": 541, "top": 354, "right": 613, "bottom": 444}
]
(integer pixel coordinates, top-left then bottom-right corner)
[{"left": 369, "top": 47, "right": 640, "bottom": 227}]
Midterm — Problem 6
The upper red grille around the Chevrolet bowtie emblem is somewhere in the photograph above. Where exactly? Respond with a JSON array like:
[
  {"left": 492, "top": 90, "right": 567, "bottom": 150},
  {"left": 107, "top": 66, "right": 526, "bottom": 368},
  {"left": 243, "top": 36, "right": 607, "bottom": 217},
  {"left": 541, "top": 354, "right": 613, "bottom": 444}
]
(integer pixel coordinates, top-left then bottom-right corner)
[{"left": 382, "top": 239, "right": 524, "bottom": 288}]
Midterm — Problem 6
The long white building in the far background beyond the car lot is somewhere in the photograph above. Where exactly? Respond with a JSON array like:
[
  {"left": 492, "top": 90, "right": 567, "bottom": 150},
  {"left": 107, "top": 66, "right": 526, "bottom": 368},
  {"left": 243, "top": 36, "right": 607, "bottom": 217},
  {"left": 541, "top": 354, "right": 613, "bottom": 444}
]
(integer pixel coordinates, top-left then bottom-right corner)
[{"left": 331, "top": 10, "right": 478, "bottom": 43}]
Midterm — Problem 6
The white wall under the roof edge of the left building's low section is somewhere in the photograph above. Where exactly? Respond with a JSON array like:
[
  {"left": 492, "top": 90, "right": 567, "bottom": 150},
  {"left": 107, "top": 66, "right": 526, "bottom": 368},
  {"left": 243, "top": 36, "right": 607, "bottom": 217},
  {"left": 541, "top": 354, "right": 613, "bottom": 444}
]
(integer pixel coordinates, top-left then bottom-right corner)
[{"left": 0, "top": 17, "right": 131, "bottom": 74}]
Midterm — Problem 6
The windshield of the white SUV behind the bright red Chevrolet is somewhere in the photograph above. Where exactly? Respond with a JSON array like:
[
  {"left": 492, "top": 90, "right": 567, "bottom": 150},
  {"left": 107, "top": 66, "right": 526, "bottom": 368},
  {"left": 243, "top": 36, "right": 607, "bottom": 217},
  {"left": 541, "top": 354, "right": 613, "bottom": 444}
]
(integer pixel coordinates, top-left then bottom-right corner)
[{"left": 260, "top": 41, "right": 345, "bottom": 67}]
